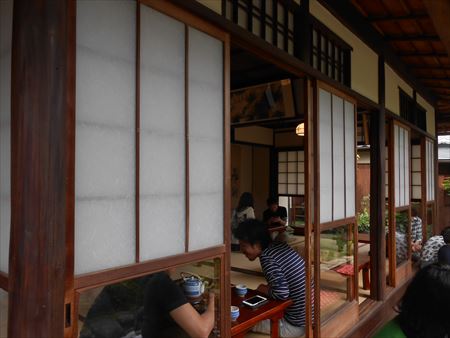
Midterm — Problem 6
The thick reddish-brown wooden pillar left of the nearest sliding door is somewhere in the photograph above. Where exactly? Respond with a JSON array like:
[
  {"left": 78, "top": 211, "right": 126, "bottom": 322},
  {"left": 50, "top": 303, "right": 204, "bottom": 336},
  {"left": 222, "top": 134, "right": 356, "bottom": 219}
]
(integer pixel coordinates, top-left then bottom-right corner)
[{"left": 8, "top": 0, "right": 75, "bottom": 338}]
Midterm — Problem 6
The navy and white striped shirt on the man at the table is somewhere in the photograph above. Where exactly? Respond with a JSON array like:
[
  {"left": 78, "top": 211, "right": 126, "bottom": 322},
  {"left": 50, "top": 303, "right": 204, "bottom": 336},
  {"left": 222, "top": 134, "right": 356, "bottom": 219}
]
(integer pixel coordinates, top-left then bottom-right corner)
[{"left": 259, "top": 242, "right": 306, "bottom": 326}]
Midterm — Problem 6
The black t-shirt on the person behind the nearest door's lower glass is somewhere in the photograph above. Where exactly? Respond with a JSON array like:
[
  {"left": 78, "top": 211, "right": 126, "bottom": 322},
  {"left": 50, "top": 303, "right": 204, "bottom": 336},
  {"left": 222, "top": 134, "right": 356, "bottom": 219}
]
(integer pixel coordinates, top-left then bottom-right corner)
[{"left": 142, "top": 272, "right": 189, "bottom": 338}]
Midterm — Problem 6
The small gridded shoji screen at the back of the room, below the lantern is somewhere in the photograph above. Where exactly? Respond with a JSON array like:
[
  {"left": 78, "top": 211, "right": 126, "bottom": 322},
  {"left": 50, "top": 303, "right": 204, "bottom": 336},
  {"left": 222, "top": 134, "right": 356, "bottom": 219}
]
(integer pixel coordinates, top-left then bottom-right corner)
[{"left": 278, "top": 150, "right": 305, "bottom": 195}]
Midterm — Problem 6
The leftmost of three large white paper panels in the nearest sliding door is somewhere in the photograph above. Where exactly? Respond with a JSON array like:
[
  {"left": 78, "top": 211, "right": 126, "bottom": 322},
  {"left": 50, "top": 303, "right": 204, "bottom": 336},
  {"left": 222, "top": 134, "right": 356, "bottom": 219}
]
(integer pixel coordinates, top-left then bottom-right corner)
[{"left": 75, "top": 1, "right": 136, "bottom": 274}]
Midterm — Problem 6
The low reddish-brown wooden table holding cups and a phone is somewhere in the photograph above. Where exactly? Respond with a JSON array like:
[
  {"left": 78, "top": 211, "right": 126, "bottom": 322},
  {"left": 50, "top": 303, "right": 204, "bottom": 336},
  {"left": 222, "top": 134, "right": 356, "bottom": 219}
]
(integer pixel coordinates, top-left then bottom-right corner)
[{"left": 231, "top": 288, "right": 292, "bottom": 338}]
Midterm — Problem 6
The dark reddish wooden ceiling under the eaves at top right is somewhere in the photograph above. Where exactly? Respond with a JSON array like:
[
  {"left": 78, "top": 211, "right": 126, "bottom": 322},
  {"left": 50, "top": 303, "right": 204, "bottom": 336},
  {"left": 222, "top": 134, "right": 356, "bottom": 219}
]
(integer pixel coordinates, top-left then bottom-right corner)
[{"left": 351, "top": 0, "right": 450, "bottom": 134}]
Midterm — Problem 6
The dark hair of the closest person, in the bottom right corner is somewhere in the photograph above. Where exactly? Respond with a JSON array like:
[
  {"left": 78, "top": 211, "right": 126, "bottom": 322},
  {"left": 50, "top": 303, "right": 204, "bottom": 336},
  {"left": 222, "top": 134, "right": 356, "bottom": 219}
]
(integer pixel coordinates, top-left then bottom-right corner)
[{"left": 398, "top": 264, "right": 450, "bottom": 338}]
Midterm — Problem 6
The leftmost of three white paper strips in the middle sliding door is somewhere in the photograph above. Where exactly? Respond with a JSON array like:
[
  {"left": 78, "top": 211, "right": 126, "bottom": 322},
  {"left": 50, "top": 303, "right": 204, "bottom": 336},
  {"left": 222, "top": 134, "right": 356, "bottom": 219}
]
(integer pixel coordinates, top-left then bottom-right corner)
[{"left": 318, "top": 89, "right": 333, "bottom": 223}]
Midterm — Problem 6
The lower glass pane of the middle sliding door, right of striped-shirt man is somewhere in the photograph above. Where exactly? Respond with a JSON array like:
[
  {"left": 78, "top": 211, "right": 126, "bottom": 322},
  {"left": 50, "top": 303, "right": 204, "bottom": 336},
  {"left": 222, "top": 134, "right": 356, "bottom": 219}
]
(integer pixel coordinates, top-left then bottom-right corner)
[{"left": 320, "top": 225, "right": 354, "bottom": 320}]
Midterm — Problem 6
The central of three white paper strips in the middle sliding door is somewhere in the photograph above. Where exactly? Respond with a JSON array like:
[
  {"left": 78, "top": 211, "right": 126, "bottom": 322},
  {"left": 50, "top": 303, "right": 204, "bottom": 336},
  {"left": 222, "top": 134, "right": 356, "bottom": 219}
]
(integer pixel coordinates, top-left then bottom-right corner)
[{"left": 332, "top": 95, "right": 345, "bottom": 220}]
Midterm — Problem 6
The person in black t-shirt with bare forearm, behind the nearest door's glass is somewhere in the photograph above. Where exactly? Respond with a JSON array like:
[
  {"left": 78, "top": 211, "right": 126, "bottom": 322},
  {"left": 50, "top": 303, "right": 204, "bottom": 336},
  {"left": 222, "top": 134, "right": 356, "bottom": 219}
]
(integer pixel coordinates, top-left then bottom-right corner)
[{"left": 142, "top": 272, "right": 214, "bottom": 338}]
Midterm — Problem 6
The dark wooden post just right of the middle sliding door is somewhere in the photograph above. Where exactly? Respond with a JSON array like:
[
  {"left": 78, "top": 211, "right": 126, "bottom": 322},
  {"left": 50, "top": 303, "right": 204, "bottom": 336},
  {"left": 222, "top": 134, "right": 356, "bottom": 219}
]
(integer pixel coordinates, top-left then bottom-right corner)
[{"left": 370, "top": 56, "right": 386, "bottom": 300}]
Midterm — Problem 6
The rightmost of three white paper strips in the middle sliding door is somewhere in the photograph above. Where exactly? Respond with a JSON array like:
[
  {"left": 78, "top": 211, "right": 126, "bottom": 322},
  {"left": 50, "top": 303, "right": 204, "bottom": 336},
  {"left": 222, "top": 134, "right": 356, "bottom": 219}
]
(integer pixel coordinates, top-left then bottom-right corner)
[{"left": 345, "top": 101, "right": 356, "bottom": 217}]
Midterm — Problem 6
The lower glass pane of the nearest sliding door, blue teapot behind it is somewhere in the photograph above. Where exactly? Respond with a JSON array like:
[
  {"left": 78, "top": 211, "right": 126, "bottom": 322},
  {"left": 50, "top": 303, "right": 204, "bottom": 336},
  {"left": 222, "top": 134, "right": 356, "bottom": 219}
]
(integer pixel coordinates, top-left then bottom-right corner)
[{"left": 78, "top": 259, "right": 220, "bottom": 338}]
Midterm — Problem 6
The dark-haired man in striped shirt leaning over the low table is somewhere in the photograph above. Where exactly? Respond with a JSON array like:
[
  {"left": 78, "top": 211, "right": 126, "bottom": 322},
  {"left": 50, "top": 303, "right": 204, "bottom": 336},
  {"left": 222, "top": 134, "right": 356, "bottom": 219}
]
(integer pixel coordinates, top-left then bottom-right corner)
[{"left": 235, "top": 219, "right": 306, "bottom": 337}]
